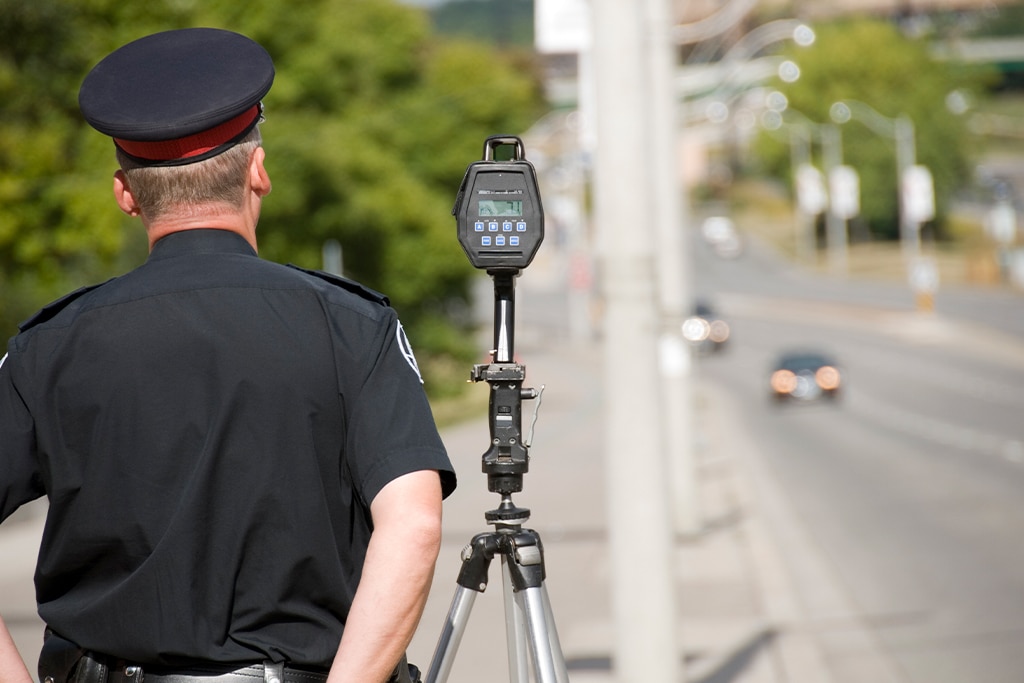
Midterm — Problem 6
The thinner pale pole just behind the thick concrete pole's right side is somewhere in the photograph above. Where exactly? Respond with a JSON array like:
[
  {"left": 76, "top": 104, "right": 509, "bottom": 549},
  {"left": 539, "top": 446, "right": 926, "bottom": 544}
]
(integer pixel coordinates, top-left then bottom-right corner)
[{"left": 644, "top": 0, "right": 700, "bottom": 536}]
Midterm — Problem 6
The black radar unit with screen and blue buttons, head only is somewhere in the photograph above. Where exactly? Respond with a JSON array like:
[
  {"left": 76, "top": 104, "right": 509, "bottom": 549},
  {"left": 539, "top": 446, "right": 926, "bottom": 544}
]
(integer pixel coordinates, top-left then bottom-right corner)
[{"left": 452, "top": 135, "right": 544, "bottom": 272}]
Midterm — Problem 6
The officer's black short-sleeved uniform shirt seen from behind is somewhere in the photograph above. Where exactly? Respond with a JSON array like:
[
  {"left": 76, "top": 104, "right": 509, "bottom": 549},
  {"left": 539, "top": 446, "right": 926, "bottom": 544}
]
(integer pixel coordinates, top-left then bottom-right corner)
[{"left": 0, "top": 230, "right": 455, "bottom": 667}]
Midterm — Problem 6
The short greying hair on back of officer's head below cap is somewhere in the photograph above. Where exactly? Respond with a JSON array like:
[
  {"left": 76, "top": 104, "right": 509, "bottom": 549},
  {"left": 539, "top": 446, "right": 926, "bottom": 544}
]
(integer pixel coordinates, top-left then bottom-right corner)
[{"left": 117, "top": 126, "right": 262, "bottom": 220}]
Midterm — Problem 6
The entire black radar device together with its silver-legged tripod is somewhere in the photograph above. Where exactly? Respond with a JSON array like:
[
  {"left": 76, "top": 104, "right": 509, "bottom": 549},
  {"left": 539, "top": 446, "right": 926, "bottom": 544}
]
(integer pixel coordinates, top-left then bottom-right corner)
[{"left": 424, "top": 135, "right": 568, "bottom": 683}]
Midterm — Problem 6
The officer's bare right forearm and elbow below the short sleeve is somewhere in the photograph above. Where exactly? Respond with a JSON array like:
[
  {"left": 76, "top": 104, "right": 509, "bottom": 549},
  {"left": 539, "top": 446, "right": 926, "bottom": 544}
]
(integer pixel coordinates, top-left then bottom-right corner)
[{"left": 328, "top": 470, "right": 441, "bottom": 683}]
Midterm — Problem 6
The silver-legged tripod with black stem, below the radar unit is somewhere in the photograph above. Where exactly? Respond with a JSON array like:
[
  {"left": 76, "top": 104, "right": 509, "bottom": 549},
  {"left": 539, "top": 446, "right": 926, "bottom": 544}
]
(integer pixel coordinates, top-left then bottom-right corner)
[{"left": 426, "top": 269, "right": 568, "bottom": 683}]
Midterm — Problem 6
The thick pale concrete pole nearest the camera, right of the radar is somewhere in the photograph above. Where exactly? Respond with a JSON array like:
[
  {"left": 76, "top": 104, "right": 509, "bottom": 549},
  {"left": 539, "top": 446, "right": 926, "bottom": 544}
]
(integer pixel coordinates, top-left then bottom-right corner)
[{"left": 591, "top": 0, "right": 682, "bottom": 683}]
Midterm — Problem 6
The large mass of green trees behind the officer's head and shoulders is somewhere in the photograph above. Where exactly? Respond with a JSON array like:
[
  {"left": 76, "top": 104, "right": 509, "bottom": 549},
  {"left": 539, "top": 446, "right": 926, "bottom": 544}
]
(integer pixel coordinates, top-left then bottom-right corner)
[{"left": 0, "top": 0, "right": 543, "bottom": 395}]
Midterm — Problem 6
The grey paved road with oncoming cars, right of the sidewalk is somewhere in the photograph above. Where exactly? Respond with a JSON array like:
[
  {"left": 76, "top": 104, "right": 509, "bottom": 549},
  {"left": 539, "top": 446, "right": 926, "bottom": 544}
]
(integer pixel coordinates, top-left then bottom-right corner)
[{"left": 698, "top": 231, "right": 1024, "bottom": 683}]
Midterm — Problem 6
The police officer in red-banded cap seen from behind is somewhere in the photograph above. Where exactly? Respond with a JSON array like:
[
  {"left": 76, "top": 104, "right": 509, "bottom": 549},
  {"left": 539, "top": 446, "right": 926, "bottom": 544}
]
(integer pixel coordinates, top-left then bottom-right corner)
[{"left": 0, "top": 29, "right": 455, "bottom": 683}]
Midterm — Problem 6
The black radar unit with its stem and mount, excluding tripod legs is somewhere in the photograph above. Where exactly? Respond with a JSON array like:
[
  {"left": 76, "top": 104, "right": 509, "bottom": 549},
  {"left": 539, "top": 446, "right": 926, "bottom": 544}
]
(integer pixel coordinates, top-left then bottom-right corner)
[{"left": 452, "top": 135, "right": 544, "bottom": 524}]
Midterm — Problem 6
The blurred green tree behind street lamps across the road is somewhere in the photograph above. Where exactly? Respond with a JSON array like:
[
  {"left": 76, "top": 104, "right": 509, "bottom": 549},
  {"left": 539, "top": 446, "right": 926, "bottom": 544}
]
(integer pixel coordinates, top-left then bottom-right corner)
[{"left": 760, "top": 19, "right": 985, "bottom": 238}]
